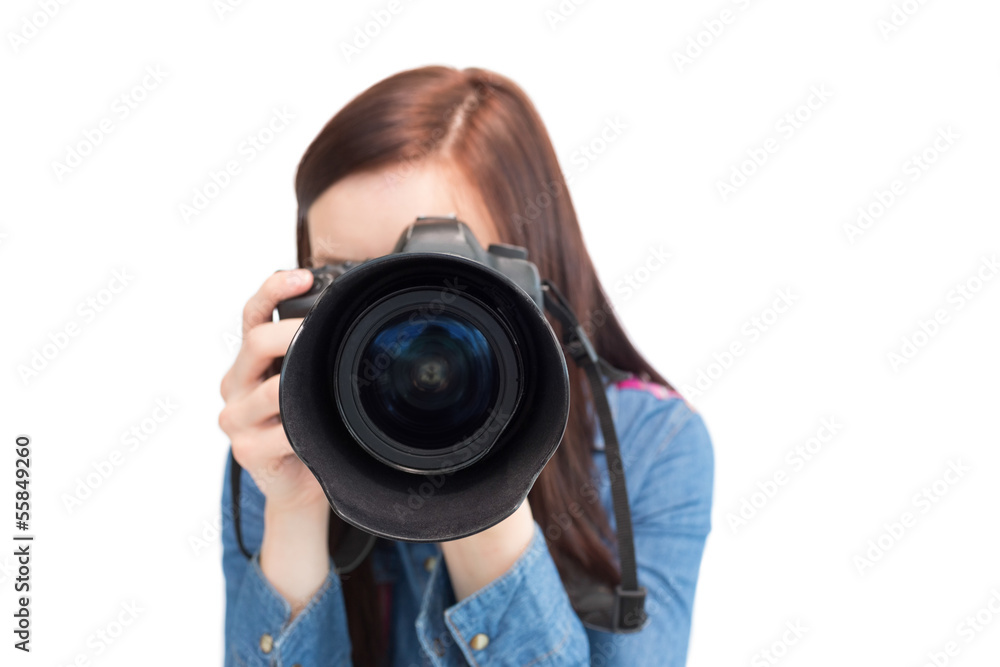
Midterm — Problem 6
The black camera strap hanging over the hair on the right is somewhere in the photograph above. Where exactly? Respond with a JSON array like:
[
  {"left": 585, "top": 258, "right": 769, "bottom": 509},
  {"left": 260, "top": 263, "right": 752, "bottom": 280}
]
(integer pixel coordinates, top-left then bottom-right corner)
[{"left": 542, "top": 280, "right": 646, "bottom": 632}]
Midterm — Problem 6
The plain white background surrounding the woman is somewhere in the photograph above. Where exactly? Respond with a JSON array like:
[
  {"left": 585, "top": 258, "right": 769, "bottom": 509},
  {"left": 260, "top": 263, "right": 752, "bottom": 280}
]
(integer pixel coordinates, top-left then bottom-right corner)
[{"left": 0, "top": 0, "right": 1000, "bottom": 667}]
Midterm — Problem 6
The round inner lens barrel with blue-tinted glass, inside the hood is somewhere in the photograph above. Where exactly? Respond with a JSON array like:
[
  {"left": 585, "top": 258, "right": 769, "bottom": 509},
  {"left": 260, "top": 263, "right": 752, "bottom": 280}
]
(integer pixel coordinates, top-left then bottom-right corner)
[{"left": 332, "top": 288, "right": 523, "bottom": 473}]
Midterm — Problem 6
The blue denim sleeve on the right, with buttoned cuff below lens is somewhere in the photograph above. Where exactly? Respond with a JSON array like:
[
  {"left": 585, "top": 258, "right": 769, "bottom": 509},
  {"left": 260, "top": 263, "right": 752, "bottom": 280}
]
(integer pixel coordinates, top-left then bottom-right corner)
[{"left": 416, "top": 401, "right": 714, "bottom": 667}]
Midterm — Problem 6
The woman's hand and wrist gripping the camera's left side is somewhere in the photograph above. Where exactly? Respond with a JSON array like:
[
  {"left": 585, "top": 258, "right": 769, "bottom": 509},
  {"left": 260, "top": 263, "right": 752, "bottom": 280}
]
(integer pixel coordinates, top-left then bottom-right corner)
[{"left": 219, "top": 269, "right": 330, "bottom": 617}]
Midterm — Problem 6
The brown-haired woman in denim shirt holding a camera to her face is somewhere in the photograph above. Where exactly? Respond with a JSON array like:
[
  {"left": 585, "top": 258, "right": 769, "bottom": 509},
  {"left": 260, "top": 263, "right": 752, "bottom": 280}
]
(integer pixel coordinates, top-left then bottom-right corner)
[{"left": 219, "top": 67, "right": 713, "bottom": 667}]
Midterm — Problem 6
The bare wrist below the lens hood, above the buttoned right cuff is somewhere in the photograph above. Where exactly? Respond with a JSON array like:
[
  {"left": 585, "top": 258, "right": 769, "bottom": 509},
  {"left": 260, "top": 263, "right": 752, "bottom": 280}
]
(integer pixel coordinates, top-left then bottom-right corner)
[{"left": 441, "top": 499, "right": 535, "bottom": 601}]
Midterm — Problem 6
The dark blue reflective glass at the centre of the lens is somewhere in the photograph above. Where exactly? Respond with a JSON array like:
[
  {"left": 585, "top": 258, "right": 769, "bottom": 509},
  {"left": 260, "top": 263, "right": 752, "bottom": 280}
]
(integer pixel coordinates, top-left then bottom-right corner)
[{"left": 359, "top": 312, "right": 499, "bottom": 450}]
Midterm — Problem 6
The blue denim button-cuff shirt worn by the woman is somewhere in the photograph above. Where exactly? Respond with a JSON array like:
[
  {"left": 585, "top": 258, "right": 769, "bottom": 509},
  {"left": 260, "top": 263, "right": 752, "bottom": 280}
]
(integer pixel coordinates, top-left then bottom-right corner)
[{"left": 222, "top": 378, "right": 714, "bottom": 667}]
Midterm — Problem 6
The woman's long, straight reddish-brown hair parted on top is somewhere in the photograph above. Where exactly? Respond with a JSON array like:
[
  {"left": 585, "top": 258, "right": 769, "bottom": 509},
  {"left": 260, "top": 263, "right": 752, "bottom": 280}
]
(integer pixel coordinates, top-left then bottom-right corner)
[{"left": 295, "top": 66, "right": 669, "bottom": 665}]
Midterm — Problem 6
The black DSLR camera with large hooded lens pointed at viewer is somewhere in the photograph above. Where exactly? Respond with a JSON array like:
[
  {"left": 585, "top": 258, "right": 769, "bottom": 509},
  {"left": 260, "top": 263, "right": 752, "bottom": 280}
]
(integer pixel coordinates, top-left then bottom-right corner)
[{"left": 278, "top": 217, "right": 569, "bottom": 542}]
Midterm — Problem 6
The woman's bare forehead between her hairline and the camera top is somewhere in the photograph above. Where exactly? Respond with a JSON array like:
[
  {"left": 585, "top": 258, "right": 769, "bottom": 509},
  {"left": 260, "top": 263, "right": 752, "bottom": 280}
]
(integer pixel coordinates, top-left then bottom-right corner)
[{"left": 306, "top": 163, "right": 497, "bottom": 265}]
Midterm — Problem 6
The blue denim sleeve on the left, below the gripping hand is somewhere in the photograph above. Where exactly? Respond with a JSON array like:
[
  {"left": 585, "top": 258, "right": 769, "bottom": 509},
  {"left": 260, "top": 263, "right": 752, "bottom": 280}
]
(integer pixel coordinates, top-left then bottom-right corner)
[{"left": 222, "top": 448, "right": 351, "bottom": 667}]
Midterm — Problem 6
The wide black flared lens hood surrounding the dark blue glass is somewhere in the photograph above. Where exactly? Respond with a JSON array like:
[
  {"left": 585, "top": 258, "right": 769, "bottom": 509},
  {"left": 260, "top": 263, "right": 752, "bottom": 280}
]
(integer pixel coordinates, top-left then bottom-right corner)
[{"left": 279, "top": 252, "right": 569, "bottom": 542}]
